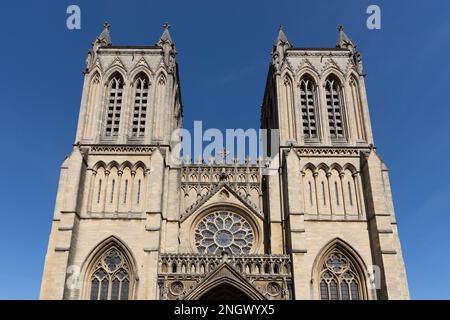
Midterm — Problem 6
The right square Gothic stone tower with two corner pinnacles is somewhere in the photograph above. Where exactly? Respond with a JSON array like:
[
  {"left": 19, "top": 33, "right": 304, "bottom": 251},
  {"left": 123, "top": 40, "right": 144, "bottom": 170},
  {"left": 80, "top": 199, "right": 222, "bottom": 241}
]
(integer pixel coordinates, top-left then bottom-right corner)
[{"left": 261, "top": 27, "right": 409, "bottom": 299}]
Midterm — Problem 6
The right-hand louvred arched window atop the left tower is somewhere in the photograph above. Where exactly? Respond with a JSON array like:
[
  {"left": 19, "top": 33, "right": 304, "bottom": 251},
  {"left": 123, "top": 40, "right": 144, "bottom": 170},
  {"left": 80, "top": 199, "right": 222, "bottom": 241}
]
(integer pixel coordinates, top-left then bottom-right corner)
[{"left": 131, "top": 73, "right": 149, "bottom": 137}]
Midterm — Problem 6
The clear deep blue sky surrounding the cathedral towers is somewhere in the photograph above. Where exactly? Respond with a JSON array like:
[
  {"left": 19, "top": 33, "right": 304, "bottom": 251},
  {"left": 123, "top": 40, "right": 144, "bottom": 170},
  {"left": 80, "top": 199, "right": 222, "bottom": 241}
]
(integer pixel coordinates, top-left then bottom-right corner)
[{"left": 0, "top": 0, "right": 450, "bottom": 299}]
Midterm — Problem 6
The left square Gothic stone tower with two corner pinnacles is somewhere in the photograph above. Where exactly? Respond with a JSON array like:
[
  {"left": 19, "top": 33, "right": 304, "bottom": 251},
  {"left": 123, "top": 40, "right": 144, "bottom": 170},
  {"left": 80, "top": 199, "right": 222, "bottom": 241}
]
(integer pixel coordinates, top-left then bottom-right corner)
[{"left": 41, "top": 23, "right": 182, "bottom": 299}]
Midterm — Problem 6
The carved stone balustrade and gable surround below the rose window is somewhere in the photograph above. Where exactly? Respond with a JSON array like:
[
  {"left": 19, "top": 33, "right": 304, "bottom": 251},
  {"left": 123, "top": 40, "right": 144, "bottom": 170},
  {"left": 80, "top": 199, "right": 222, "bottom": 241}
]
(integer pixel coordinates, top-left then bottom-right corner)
[{"left": 158, "top": 254, "right": 292, "bottom": 300}]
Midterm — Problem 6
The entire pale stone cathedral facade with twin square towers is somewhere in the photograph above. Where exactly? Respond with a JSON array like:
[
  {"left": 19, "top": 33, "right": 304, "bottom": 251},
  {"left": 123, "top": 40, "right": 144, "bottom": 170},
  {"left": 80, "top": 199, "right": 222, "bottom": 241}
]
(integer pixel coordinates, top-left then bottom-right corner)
[{"left": 40, "top": 23, "right": 409, "bottom": 300}]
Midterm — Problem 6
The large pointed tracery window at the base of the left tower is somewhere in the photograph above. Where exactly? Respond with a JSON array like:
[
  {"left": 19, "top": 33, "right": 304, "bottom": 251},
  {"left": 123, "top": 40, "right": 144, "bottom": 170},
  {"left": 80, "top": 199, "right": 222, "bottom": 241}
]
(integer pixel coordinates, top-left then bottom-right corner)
[{"left": 89, "top": 245, "right": 133, "bottom": 300}]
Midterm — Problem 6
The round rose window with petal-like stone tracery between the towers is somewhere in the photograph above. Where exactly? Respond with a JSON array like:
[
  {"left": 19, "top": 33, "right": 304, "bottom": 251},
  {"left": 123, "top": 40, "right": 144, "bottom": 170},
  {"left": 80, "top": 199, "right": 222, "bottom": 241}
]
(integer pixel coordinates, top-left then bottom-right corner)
[{"left": 194, "top": 211, "right": 255, "bottom": 254}]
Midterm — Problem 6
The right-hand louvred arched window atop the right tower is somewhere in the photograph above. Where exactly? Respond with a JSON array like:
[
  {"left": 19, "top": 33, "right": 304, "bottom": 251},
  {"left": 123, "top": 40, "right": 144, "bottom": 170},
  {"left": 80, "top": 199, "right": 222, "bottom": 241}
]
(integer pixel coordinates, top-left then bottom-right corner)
[{"left": 325, "top": 76, "right": 344, "bottom": 139}]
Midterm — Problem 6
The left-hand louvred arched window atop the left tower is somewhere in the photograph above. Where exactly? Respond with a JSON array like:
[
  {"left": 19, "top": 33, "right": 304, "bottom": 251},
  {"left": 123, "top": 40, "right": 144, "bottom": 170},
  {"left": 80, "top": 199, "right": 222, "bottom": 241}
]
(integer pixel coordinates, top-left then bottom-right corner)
[{"left": 105, "top": 73, "right": 123, "bottom": 137}]
